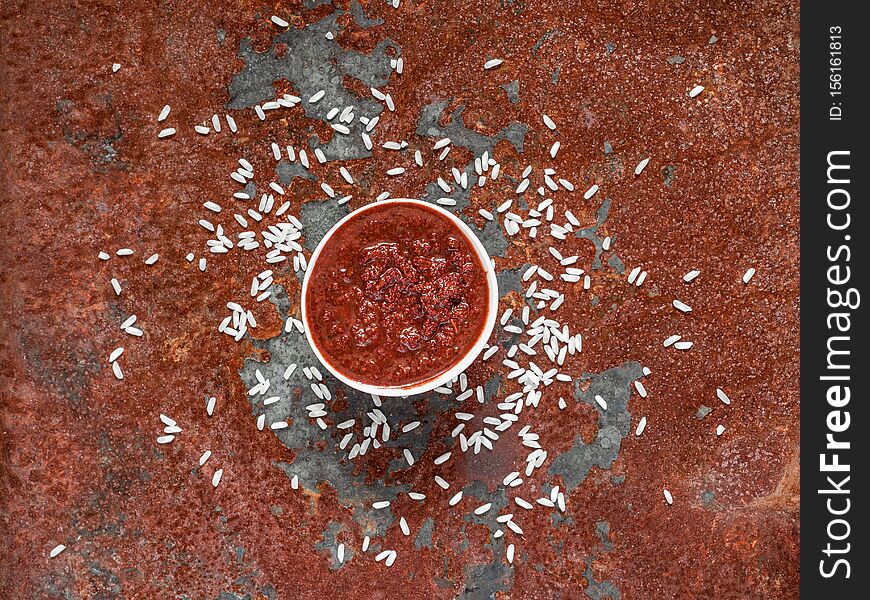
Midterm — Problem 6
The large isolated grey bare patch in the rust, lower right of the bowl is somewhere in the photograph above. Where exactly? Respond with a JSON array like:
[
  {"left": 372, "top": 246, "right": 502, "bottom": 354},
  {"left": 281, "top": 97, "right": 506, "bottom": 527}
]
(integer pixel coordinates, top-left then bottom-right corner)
[{"left": 548, "top": 361, "right": 643, "bottom": 492}]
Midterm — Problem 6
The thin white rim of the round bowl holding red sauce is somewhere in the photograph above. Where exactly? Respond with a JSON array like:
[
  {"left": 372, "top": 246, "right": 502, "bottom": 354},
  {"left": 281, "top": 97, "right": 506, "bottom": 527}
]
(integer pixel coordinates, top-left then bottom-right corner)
[{"left": 302, "top": 198, "right": 498, "bottom": 396}]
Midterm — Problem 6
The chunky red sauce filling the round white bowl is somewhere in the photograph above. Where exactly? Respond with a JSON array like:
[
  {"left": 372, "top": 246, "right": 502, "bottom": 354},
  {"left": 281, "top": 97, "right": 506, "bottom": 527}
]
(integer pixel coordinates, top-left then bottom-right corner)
[{"left": 305, "top": 203, "right": 489, "bottom": 386}]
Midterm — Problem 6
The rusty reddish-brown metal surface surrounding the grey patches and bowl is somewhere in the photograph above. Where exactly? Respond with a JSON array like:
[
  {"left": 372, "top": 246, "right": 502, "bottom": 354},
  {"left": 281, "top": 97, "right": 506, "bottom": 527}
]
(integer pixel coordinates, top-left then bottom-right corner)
[{"left": 0, "top": 0, "right": 800, "bottom": 600}]
